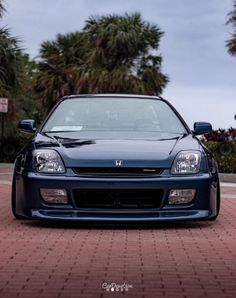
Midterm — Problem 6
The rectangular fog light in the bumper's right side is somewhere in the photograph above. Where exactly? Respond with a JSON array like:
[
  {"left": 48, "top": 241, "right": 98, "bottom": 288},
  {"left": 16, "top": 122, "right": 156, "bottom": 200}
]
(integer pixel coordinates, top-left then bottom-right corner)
[{"left": 168, "top": 189, "right": 196, "bottom": 205}]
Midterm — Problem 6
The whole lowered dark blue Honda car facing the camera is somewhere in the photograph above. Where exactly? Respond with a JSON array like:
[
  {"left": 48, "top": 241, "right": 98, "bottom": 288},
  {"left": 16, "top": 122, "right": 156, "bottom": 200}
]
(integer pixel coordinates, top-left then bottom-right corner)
[{"left": 12, "top": 94, "right": 220, "bottom": 221}]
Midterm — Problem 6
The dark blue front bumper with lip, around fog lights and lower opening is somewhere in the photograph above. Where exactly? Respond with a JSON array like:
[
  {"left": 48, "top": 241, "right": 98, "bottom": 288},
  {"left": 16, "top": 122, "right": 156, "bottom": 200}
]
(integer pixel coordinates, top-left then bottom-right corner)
[{"left": 16, "top": 171, "right": 217, "bottom": 222}]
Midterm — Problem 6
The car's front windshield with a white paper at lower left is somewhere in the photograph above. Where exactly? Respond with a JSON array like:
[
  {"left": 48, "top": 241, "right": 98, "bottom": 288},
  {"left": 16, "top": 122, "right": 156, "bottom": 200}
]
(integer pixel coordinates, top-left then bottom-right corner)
[{"left": 42, "top": 97, "right": 187, "bottom": 138}]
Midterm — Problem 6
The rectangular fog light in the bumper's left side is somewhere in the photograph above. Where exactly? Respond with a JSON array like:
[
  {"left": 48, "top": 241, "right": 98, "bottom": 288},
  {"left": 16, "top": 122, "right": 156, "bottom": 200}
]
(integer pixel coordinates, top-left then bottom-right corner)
[{"left": 40, "top": 188, "right": 68, "bottom": 204}]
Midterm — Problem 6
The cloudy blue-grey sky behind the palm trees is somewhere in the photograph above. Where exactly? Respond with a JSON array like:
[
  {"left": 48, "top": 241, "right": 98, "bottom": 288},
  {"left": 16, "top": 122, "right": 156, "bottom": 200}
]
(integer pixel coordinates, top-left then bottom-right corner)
[{"left": 0, "top": 0, "right": 236, "bottom": 129}]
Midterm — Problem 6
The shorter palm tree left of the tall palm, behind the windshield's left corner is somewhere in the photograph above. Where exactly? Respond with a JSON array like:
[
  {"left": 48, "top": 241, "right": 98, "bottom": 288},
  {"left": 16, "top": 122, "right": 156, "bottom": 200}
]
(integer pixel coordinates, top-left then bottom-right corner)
[{"left": 35, "top": 32, "right": 84, "bottom": 110}]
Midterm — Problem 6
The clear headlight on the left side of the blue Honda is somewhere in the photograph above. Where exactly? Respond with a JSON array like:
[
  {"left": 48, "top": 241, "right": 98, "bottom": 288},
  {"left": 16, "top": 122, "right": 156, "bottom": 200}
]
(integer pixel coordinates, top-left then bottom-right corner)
[{"left": 33, "top": 149, "right": 65, "bottom": 173}]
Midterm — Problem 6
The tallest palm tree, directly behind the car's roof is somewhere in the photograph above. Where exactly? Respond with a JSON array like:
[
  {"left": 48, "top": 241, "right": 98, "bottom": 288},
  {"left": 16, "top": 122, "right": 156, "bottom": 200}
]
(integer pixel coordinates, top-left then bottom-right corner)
[{"left": 77, "top": 13, "right": 168, "bottom": 95}]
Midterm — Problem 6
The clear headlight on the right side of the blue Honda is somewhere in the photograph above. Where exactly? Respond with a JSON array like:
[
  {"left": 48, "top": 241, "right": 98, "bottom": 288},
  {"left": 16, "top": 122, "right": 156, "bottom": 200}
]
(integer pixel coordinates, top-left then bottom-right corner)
[{"left": 171, "top": 151, "right": 201, "bottom": 174}]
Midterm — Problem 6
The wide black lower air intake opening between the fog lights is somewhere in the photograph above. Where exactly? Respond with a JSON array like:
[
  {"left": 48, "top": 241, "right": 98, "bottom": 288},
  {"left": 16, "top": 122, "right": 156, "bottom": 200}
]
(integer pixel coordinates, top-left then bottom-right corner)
[{"left": 74, "top": 189, "right": 163, "bottom": 210}]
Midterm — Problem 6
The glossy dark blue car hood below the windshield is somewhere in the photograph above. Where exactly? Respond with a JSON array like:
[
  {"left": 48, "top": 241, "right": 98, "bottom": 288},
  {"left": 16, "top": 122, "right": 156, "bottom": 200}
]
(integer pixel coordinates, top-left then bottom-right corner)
[{"left": 34, "top": 134, "right": 200, "bottom": 168}]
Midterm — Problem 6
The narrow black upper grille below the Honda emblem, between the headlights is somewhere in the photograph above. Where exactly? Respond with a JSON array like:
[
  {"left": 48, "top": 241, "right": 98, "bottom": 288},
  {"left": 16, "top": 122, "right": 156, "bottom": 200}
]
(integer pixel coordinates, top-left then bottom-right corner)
[{"left": 73, "top": 167, "right": 163, "bottom": 178}]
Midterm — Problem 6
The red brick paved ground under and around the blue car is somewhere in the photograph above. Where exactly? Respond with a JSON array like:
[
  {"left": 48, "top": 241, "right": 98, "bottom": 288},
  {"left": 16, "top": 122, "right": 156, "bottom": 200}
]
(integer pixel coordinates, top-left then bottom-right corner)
[{"left": 0, "top": 168, "right": 236, "bottom": 298}]
